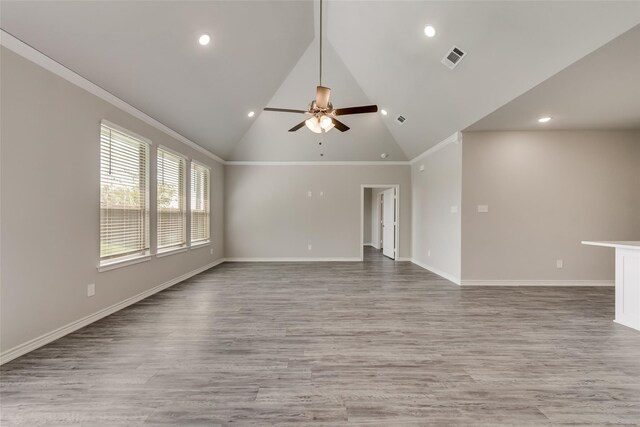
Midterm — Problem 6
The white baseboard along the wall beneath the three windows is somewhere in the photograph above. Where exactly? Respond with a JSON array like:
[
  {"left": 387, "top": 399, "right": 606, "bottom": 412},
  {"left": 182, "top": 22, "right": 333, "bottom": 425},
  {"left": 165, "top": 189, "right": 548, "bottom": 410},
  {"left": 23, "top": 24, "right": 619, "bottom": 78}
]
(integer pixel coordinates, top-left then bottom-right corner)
[{"left": 0, "top": 259, "right": 225, "bottom": 365}]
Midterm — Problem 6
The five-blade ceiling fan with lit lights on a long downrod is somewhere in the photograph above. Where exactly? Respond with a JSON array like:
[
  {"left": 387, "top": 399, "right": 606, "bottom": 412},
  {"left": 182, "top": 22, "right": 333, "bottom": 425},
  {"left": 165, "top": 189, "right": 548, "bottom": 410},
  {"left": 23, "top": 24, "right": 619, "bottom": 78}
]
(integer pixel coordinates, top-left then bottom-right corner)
[{"left": 264, "top": 0, "right": 378, "bottom": 133}]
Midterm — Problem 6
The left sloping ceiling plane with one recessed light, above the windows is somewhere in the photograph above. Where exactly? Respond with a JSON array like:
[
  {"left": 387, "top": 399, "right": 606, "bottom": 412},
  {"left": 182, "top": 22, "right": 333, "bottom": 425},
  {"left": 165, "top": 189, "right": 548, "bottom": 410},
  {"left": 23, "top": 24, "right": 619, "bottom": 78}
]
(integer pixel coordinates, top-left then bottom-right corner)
[{"left": 0, "top": 0, "right": 314, "bottom": 158}]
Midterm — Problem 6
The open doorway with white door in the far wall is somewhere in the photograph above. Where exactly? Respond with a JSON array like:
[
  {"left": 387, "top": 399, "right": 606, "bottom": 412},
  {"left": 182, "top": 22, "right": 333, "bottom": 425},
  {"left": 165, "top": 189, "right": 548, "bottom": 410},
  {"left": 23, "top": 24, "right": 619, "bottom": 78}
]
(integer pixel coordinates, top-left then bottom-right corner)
[{"left": 360, "top": 184, "right": 400, "bottom": 261}]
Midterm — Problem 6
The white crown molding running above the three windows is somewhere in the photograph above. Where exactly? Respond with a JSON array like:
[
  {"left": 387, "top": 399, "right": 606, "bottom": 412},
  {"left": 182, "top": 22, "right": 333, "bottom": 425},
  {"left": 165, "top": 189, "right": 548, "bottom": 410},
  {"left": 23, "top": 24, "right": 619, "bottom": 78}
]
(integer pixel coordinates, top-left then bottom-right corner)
[{"left": 0, "top": 29, "right": 225, "bottom": 163}]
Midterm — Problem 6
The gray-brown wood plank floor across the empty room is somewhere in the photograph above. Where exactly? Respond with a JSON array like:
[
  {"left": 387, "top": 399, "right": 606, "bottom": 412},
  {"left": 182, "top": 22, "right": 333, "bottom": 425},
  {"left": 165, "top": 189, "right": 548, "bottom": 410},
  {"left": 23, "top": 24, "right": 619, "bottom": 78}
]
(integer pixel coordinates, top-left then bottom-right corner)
[{"left": 1, "top": 250, "right": 640, "bottom": 427}]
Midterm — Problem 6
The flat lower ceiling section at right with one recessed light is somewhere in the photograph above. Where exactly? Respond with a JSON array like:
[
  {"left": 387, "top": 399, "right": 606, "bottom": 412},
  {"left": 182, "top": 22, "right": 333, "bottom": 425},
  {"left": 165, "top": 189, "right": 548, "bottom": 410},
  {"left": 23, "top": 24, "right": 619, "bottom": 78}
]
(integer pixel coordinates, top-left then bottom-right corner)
[{"left": 466, "top": 25, "right": 640, "bottom": 131}]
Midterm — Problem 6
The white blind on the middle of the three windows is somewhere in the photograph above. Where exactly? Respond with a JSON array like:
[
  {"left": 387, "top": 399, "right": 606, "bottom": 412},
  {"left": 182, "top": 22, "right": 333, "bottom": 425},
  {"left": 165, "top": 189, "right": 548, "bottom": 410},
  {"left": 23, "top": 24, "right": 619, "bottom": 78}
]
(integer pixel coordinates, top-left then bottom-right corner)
[{"left": 157, "top": 148, "right": 187, "bottom": 250}]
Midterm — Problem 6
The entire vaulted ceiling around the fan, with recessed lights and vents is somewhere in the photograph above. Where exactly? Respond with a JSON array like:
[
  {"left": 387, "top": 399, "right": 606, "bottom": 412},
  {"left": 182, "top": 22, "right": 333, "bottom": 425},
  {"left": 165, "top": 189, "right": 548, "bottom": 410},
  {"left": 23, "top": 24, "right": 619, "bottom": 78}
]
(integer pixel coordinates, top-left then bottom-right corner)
[{"left": 0, "top": 0, "right": 640, "bottom": 161}]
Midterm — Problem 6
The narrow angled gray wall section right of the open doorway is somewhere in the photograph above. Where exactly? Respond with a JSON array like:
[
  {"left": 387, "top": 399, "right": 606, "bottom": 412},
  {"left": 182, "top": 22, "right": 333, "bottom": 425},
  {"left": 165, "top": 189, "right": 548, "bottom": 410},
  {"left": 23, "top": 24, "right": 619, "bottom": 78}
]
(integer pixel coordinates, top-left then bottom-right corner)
[{"left": 411, "top": 143, "right": 462, "bottom": 281}]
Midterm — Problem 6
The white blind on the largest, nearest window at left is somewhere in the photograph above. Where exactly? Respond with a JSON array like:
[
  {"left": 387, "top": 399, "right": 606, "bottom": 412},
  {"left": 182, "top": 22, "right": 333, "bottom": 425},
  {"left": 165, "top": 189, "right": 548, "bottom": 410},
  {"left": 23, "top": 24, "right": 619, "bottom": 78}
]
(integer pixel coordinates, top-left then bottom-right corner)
[{"left": 100, "top": 123, "right": 149, "bottom": 263}]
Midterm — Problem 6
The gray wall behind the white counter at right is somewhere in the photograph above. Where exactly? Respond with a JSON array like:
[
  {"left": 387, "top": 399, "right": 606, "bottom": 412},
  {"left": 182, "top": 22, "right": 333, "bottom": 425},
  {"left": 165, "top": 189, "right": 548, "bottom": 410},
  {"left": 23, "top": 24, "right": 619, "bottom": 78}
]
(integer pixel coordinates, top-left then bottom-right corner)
[{"left": 462, "top": 131, "right": 640, "bottom": 281}]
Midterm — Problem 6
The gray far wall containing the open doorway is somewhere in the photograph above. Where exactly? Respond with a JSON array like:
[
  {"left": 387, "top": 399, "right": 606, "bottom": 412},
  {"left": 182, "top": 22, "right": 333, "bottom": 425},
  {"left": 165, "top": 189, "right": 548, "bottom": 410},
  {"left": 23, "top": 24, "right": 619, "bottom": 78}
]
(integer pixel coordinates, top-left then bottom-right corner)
[{"left": 225, "top": 165, "right": 411, "bottom": 258}]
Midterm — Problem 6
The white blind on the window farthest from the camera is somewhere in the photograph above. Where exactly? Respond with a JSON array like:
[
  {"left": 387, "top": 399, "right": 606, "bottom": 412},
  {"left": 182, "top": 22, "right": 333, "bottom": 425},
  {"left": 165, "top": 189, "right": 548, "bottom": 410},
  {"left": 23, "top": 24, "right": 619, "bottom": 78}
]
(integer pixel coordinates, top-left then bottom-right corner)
[{"left": 191, "top": 162, "right": 209, "bottom": 243}]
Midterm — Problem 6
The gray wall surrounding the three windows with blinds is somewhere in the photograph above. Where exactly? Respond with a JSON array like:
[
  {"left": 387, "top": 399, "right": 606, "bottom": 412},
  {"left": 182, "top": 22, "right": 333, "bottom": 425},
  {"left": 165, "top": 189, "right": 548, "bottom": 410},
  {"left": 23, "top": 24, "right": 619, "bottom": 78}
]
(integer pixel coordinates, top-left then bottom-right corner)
[{"left": 0, "top": 47, "right": 224, "bottom": 352}]
